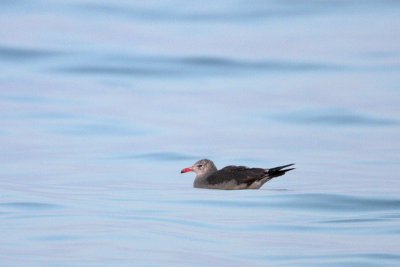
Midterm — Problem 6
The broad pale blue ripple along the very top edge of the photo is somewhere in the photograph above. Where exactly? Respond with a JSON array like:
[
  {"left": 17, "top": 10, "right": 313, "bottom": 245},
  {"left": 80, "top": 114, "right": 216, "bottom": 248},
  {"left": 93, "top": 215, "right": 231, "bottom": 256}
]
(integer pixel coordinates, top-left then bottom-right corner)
[{"left": 76, "top": 1, "right": 382, "bottom": 23}]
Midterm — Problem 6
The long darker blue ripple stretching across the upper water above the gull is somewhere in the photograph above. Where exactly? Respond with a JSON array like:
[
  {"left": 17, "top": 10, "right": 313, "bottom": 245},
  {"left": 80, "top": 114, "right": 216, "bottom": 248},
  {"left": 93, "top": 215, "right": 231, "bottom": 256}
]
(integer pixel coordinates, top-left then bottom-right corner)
[{"left": 53, "top": 55, "right": 347, "bottom": 77}]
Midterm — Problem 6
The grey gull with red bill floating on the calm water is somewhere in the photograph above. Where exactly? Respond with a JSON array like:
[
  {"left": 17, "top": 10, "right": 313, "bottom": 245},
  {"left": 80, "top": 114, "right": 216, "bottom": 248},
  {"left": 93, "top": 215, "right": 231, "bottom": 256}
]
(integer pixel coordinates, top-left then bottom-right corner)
[{"left": 181, "top": 159, "right": 294, "bottom": 190}]
